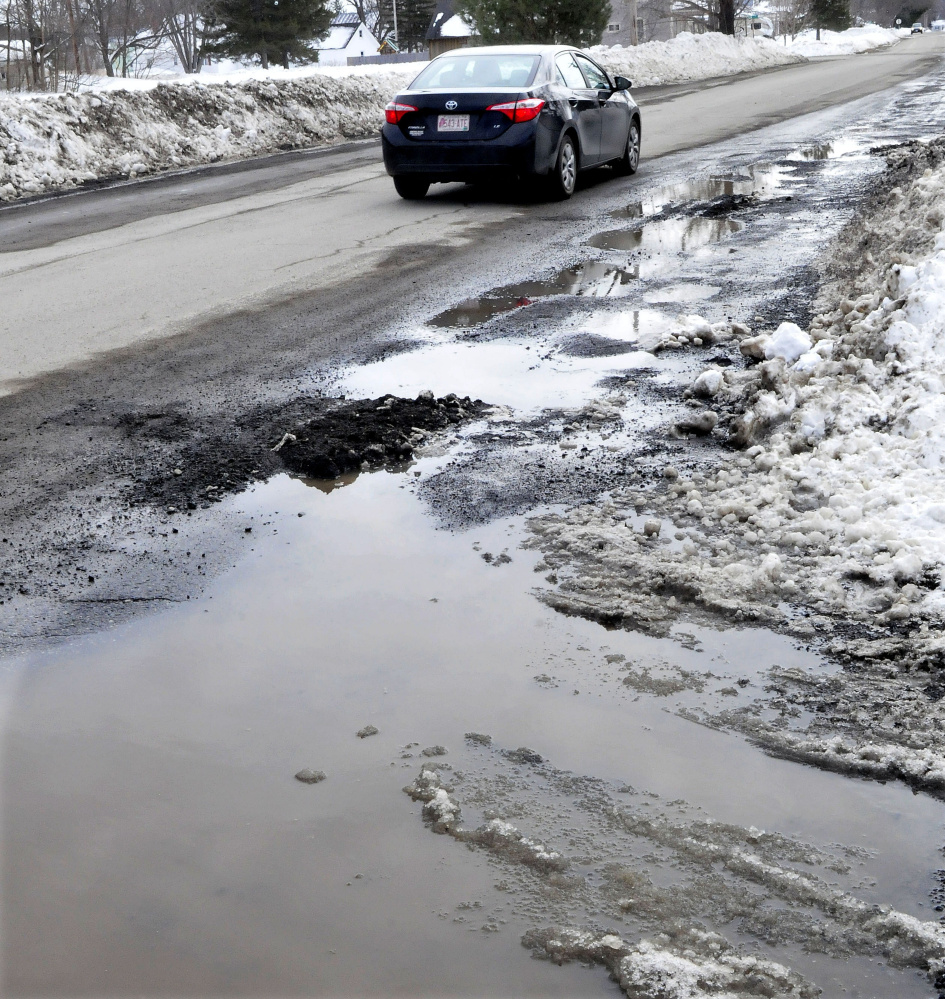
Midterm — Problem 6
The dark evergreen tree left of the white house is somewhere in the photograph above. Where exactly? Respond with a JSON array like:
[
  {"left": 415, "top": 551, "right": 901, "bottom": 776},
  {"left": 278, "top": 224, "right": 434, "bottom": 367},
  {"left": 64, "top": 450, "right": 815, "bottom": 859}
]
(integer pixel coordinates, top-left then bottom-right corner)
[{"left": 205, "top": 0, "right": 334, "bottom": 69}]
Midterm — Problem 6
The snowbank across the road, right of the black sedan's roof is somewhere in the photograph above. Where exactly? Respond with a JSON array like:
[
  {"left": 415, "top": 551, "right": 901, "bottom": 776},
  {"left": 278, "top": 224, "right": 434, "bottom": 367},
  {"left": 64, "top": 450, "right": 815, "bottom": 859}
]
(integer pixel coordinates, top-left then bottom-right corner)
[{"left": 588, "top": 31, "right": 806, "bottom": 87}]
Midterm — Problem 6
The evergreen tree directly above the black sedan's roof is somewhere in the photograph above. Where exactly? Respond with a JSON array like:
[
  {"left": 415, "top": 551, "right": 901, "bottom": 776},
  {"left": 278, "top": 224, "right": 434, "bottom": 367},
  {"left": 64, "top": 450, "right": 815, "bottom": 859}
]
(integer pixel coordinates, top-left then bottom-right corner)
[{"left": 458, "top": 0, "right": 610, "bottom": 47}]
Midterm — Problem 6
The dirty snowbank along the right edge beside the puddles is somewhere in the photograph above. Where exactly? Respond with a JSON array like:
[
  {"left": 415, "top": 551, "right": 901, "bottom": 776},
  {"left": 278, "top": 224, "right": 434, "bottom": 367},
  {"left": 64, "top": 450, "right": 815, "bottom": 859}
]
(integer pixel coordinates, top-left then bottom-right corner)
[{"left": 532, "top": 139, "right": 945, "bottom": 794}]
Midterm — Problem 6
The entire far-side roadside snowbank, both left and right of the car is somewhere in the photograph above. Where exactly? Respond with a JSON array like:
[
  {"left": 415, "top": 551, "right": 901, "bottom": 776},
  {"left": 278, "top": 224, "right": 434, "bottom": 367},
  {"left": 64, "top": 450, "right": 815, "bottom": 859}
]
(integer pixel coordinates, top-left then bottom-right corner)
[{"left": 0, "top": 29, "right": 900, "bottom": 201}]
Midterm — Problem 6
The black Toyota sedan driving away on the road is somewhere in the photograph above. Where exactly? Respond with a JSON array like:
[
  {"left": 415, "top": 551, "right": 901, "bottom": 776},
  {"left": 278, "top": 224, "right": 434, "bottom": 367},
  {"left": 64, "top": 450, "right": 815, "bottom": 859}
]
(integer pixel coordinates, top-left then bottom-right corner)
[{"left": 381, "top": 45, "right": 641, "bottom": 199}]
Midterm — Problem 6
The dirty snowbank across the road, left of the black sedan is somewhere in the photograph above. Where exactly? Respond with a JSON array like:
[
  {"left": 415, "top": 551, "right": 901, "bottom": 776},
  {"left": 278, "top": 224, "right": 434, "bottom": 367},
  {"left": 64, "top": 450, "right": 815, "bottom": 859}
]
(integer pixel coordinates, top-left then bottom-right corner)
[{"left": 0, "top": 72, "right": 409, "bottom": 201}]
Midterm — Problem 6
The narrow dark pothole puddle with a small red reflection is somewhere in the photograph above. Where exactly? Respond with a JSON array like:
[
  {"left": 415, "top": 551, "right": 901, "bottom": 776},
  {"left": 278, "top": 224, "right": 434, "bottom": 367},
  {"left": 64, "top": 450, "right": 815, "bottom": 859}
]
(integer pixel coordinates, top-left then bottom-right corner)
[{"left": 429, "top": 260, "right": 639, "bottom": 327}]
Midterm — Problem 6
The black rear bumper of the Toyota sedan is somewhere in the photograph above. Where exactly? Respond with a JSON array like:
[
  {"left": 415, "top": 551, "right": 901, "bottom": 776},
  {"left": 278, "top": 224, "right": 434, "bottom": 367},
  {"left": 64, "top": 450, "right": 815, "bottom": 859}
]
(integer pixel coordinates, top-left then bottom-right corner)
[{"left": 381, "top": 123, "right": 557, "bottom": 182}]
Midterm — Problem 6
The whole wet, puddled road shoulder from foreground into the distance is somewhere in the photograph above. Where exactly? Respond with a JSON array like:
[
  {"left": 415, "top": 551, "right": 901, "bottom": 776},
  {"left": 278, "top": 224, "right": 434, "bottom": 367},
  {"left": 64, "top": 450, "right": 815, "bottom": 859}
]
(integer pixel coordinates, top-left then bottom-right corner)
[{"left": 0, "top": 64, "right": 943, "bottom": 999}]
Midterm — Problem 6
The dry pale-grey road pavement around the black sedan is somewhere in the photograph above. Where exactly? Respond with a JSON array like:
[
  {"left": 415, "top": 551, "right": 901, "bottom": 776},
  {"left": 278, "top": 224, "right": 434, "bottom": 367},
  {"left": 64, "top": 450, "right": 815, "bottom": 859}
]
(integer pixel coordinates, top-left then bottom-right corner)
[{"left": 0, "top": 34, "right": 945, "bottom": 392}]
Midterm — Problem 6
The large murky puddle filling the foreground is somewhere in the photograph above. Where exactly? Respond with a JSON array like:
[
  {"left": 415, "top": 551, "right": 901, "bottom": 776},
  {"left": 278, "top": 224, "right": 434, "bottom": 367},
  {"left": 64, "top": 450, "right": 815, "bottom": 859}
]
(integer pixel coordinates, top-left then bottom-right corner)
[{"left": 2, "top": 470, "right": 942, "bottom": 997}]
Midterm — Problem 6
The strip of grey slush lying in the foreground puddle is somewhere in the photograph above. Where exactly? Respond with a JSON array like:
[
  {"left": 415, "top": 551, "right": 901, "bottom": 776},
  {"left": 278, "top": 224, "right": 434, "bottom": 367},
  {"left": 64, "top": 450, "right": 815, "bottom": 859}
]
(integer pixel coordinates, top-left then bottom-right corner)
[{"left": 404, "top": 745, "right": 945, "bottom": 999}]
